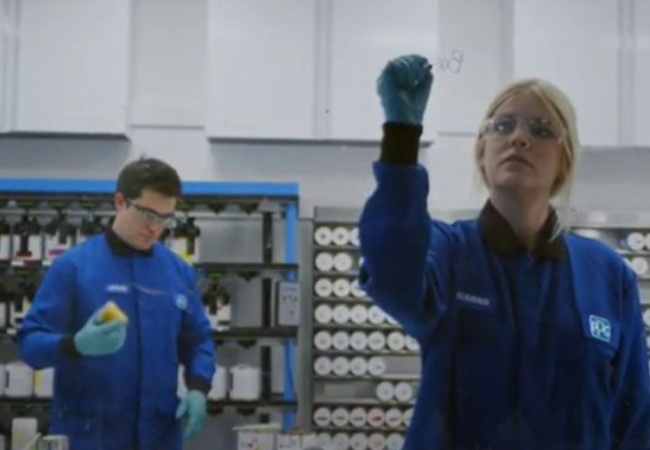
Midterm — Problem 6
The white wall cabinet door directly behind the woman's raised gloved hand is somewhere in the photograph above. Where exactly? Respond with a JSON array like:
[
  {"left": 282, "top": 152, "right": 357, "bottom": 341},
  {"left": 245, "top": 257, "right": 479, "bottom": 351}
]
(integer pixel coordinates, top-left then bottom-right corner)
[{"left": 326, "top": 0, "right": 438, "bottom": 140}]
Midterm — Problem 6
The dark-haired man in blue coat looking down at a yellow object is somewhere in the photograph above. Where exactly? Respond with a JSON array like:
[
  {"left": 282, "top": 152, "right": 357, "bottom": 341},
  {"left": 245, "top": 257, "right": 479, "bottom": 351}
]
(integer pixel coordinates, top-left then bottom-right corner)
[{"left": 18, "top": 158, "right": 215, "bottom": 450}]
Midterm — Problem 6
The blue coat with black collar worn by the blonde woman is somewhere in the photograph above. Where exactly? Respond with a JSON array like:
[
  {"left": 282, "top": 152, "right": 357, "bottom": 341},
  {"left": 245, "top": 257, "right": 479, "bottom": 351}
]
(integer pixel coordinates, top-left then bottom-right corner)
[{"left": 359, "top": 162, "right": 650, "bottom": 450}]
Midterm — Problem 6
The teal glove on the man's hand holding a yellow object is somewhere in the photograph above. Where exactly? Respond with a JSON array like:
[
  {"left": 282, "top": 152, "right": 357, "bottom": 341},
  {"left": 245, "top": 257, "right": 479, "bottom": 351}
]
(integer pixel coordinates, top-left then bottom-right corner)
[{"left": 73, "top": 308, "right": 126, "bottom": 356}]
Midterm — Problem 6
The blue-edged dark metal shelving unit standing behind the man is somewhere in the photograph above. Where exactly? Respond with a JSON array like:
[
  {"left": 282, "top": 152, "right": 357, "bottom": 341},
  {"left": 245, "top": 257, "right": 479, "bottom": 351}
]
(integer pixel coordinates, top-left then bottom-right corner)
[{"left": 0, "top": 179, "right": 302, "bottom": 442}]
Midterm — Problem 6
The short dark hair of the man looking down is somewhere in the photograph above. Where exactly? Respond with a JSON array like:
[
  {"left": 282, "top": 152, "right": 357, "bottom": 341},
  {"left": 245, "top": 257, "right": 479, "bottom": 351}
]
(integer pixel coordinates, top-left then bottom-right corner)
[{"left": 117, "top": 157, "right": 181, "bottom": 199}]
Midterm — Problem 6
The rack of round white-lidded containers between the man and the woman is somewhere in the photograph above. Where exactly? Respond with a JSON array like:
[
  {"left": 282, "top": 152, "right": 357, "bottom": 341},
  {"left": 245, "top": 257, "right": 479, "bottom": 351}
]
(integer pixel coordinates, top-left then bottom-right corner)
[{"left": 305, "top": 208, "right": 420, "bottom": 448}]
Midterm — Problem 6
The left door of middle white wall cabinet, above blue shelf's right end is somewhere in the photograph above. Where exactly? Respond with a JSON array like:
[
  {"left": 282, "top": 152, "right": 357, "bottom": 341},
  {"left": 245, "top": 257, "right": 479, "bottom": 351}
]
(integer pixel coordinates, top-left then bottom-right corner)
[{"left": 206, "top": 0, "right": 317, "bottom": 139}]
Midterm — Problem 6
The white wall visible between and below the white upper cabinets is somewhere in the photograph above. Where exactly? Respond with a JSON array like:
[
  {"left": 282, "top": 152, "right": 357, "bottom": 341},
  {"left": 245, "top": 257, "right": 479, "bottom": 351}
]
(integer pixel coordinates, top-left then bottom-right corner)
[{"left": 0, "top": 0, "right": 648, "bottom": 216}]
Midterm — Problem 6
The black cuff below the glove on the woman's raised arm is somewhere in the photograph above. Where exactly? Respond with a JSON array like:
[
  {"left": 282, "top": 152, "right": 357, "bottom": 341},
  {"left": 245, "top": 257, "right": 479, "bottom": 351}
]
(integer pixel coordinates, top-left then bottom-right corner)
[{"left": 379, "top": 122, "right": 422, "bottom": 165}]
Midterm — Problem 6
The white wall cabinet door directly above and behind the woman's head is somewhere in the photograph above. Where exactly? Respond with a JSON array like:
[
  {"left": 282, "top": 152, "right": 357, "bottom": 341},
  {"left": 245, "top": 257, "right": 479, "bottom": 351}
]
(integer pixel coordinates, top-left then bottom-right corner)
[{"left": 513, "top": 0, "right": 621, "bottom": 145}]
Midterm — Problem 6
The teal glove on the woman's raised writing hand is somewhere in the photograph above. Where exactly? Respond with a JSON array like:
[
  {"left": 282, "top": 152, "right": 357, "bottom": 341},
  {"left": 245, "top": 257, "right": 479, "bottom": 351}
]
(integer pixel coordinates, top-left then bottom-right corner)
[{"left": 377, "top": 55, "right": 433, "bottom": 125}]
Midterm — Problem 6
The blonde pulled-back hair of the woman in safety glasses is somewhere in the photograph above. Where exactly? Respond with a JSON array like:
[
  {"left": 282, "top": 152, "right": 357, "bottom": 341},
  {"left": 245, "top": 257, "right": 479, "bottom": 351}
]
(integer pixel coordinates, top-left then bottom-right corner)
[{"left": 474, "top": 78, "right": 580, "bottom": 232}]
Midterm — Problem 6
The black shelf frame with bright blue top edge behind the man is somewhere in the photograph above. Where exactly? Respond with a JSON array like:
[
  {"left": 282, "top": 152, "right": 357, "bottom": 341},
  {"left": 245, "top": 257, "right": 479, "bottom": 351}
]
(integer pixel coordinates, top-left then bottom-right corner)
[{"left": 0, "top": 178, "right": 309, "bottom": 436}]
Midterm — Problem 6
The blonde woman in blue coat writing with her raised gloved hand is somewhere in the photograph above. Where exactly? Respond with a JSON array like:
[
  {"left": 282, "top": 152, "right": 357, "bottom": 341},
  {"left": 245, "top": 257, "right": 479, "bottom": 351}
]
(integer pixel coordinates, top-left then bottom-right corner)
[{"left": 360, "top": 55, "right": 650, "bottom": 450}]
